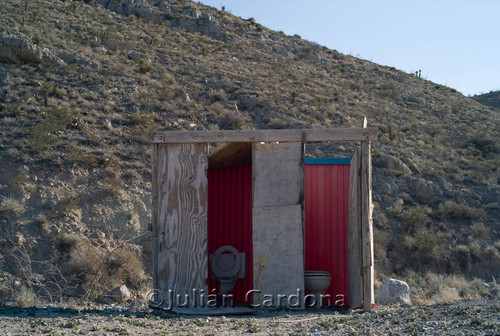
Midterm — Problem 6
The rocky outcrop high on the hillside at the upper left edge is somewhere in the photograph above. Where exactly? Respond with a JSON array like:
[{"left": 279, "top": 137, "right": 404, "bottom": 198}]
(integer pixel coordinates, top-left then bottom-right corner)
[{"left": 0, "top": 35, "right": 64, "bottom": 64}]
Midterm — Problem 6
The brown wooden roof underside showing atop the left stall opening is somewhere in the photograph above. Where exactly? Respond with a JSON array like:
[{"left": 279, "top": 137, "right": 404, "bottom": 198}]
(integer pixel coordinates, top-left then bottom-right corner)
[{"left": 208, "top": 142, "right": 252, "bottom": 169}]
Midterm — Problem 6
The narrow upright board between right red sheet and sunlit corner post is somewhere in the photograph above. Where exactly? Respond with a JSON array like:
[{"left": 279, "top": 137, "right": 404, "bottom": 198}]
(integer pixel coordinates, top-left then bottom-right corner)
[{"left": 347, "top": 149, "right": 363, "bottom": 308}]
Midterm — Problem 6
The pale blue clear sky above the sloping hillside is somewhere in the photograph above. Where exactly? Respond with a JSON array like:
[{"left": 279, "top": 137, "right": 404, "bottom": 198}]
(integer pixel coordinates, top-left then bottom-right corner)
[{"left": 201, "top": 0, "right": 500, "bottom": 95}]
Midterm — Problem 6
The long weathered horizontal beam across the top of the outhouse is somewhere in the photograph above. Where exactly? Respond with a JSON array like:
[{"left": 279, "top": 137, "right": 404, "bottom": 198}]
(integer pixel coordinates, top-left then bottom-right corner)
[{"left": 151, "top": 128, "right": 377, "bottom": 143}]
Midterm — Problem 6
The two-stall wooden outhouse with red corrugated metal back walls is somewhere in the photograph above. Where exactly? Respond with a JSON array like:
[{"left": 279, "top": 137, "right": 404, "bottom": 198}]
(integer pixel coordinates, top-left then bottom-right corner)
[{"left": 151, "top": 120, "right": 377, "bottom": 310}]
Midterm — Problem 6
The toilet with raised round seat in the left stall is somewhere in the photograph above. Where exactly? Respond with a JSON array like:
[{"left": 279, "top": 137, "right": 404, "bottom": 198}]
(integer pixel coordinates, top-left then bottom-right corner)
[{"left": 209, "top": 245, "right": 246, "bottom": 294}]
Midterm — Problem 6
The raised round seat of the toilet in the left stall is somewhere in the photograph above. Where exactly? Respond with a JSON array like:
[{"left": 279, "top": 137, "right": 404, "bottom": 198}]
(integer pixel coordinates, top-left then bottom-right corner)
[{"left": 210, "top": 245, "right": 242, "bottom": 279}]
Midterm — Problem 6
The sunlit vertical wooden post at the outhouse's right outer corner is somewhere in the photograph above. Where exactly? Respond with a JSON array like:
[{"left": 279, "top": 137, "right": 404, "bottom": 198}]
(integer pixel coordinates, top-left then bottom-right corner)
[{"left": 361, "top": 117, "right": 374, "bottom": 311}]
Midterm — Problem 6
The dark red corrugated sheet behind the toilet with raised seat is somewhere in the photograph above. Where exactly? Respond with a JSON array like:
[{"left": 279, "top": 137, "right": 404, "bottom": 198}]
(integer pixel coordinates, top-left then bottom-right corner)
[{"left": 207, "top": 165, "right": 253, "bottom": 302}]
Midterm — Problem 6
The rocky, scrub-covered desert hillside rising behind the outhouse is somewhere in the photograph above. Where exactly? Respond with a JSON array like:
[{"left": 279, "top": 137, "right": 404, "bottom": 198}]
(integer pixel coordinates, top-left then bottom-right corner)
[{"left": 0, "top": 0, "right": 500, "bottom": 302}]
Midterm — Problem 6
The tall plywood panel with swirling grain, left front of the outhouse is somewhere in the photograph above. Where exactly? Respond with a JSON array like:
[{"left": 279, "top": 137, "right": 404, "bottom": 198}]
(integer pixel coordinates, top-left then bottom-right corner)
[{"left": 153, "top": 144, "right": 208, "bottom": 306}]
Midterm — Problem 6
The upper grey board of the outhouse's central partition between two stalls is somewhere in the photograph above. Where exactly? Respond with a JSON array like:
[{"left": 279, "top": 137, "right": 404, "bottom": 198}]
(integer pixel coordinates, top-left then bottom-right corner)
[{"left": 253, "top": 142, "right": 304, "bottom": 208}]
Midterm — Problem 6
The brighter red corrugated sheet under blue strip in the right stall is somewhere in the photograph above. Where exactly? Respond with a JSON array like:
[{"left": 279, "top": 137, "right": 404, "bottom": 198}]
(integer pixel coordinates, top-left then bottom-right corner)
[{"left": 305, "top": 164, "right": 349, "bottom": 306}]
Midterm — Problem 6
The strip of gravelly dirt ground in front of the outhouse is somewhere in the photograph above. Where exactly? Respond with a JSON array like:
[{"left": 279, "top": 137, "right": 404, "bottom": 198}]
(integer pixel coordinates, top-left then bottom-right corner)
[{"left": 0, "top": 300, "right": 500, "bottom": 336}]
